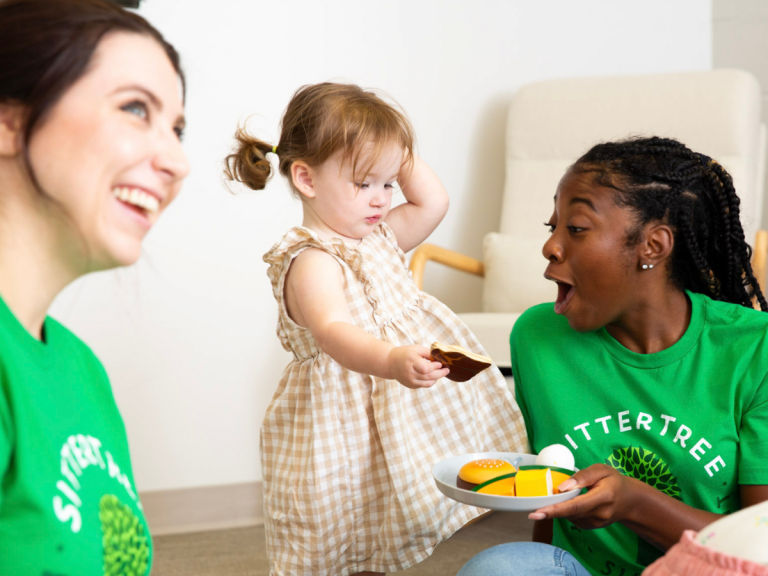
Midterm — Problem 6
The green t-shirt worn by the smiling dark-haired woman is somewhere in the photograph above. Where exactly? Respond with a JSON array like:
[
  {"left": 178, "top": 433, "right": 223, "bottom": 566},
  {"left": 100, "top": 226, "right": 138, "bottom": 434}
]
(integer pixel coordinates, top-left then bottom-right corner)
[{"left": 0, "top": 299, "right": 152, "bottom": 576}]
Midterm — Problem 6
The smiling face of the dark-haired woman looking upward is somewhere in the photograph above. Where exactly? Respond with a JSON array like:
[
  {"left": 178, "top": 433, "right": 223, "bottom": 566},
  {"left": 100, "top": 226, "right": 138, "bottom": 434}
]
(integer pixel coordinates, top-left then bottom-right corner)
[{"left": 26, "top": 32, "right": 187, "bottom": 273}]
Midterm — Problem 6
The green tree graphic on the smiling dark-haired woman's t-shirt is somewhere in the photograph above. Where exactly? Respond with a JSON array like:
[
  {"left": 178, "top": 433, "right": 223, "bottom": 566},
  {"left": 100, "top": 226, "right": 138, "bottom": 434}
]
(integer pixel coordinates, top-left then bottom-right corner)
[{"left": 99, "top": 494, "right": 149, "bottom": 576}]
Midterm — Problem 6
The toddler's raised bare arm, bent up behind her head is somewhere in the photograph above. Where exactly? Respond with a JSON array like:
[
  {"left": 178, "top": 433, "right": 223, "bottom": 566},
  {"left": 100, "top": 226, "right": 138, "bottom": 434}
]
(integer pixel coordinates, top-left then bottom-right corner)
[{"left": 386, "top": 156, "right": 449, "bottom": 252}]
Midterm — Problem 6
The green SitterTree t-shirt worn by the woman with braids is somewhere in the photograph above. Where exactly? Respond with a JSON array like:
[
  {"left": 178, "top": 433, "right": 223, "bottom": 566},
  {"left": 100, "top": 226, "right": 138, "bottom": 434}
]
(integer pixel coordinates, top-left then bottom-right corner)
[{"left": 510, "top": 292, "right": 768, "bottom": 576}]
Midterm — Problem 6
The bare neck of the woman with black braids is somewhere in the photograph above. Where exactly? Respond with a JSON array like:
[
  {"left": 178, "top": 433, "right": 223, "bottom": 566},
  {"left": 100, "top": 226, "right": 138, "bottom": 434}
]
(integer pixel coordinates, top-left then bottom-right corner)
[{"left": 605, "top": 287, "right": 691, "bottom": 354}]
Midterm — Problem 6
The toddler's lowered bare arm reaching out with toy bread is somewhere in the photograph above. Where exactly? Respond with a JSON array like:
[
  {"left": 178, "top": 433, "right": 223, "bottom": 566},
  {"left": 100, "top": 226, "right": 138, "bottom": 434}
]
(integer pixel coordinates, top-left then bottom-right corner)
[{"left": 285, "top": 248, "right": 448, "bottom": 388}]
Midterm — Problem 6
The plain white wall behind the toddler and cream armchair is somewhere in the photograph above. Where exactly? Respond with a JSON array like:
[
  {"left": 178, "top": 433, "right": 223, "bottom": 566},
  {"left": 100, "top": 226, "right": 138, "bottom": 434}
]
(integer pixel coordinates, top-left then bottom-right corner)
[{"left": 52, "top": 0, "right": 711, "bottom": 491}]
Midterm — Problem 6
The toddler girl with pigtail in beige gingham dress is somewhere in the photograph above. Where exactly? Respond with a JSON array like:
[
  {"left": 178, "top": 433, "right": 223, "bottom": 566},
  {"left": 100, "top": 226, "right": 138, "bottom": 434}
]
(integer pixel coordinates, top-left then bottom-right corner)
[{"left": 226, "top": 83, "right": 527, "bottom": 576}]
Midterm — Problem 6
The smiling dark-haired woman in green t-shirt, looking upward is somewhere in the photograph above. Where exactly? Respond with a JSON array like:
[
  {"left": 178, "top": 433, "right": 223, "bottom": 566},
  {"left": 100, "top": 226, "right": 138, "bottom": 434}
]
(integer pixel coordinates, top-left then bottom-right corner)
[{"left": 0, "top": 0, "right": 188, "bottom": 575}]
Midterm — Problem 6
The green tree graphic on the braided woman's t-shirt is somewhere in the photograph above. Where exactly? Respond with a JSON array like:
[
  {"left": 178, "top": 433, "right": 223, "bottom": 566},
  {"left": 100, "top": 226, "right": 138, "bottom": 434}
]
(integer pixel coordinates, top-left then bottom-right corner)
[{"left": 605, "top": 446, "right": 682, "bottom": 566}]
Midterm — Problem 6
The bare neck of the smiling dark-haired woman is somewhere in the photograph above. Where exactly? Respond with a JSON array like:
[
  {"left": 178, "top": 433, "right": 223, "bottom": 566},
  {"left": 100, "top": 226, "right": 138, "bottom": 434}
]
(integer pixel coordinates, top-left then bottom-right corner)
[{"left": 0, "top": 187, "right": 84, "bottom": 339}]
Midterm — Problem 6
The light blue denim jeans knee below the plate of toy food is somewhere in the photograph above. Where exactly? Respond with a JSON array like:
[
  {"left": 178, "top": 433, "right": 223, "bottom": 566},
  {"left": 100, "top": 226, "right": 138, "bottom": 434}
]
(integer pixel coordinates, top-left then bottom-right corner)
[{"left": 456, "top": 542, "right": 590, "bottom": 576}]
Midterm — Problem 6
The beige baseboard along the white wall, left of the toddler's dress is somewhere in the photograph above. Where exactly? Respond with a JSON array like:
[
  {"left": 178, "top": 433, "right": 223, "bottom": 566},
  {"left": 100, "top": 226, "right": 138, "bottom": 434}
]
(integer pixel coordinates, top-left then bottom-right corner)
[{"left": 141, "top": 482, "right": 264, "bottom": 536}]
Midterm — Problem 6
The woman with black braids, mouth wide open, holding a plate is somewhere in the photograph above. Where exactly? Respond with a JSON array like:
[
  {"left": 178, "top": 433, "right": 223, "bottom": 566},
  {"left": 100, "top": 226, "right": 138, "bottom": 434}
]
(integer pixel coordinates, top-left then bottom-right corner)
[{"left": 459, "top": 138, "right": 768, "bottom": 576}]
